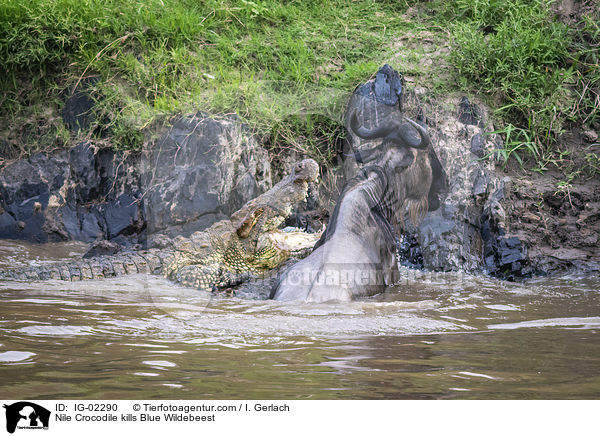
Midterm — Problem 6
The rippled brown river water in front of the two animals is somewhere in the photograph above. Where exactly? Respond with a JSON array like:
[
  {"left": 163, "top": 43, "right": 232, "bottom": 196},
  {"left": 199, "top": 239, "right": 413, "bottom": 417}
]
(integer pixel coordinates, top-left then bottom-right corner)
[{"left": 0, "top": 242, "right": 600, "bottom": 400}]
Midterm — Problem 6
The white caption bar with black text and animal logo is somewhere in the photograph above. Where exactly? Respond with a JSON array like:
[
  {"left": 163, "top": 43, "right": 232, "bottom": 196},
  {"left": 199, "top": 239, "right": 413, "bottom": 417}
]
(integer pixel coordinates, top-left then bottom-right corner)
[{"left": 0, "top": 400, "right": 600, "bottom": 436}]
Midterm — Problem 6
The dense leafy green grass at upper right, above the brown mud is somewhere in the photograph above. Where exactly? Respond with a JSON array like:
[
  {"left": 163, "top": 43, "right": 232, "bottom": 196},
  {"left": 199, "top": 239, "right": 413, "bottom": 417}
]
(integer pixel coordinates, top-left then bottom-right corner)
[{"left": 422, "top": 0, "right": 600, "bottom": 171}]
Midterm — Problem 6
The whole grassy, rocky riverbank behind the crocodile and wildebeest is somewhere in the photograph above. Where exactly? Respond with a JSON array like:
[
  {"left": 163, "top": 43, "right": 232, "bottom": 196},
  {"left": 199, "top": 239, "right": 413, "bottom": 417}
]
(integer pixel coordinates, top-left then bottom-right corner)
[{"left": 0, "top": 0, "right": 600, "bottom": 277}]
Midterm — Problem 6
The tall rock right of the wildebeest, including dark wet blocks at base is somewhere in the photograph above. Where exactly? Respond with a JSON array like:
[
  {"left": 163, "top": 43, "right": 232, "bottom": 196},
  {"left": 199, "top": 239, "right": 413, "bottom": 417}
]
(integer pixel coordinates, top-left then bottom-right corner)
[{"left": 413, "top": 97, "right": 529, "bottom": 279}]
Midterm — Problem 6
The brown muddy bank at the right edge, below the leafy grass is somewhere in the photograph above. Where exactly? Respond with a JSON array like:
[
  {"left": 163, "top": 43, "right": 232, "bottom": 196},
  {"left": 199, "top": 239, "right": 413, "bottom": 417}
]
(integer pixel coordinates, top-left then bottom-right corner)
[{"left": 508, "top": 145, "right": 600, "bottom": 274}]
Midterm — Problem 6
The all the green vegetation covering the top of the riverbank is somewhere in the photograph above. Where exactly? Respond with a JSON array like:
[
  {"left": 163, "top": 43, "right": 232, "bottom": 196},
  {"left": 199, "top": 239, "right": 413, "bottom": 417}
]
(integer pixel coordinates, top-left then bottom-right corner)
[{"left": 0, "top": 0, "right": 600, "bottom": 177}]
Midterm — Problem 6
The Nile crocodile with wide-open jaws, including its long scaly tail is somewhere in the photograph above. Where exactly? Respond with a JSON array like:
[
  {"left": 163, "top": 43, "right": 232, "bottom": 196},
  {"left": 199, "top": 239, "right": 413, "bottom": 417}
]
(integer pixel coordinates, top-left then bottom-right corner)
[{"left": 0, "top": 159, "right": 320, "bottom": 291}]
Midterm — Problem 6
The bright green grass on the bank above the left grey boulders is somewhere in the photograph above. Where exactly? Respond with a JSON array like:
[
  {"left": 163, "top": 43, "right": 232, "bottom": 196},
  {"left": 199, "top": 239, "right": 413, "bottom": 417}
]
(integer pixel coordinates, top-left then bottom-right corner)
[{"left": 0, "top": 0, "right": 414, "bottom": 164}]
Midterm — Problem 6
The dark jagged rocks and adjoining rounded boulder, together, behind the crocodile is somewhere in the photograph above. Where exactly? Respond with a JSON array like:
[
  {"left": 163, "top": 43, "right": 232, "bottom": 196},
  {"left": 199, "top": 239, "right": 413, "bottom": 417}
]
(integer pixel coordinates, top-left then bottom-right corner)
[{"left": 0, "top": 114, "right": 271, "bottom": 245}]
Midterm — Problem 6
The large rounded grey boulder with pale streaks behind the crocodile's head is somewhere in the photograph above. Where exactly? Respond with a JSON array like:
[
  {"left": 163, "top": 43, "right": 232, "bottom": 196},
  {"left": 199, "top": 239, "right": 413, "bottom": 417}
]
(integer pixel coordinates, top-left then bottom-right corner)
[{"left": 141, "top": 113, "right": 272, "bottom": 237}]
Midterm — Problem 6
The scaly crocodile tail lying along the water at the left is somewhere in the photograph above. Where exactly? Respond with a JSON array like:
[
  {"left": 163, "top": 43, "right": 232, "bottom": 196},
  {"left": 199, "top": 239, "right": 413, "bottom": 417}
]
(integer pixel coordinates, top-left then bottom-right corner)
[{"left": 0, "top": 249, "right": 174, "bottom": 281}]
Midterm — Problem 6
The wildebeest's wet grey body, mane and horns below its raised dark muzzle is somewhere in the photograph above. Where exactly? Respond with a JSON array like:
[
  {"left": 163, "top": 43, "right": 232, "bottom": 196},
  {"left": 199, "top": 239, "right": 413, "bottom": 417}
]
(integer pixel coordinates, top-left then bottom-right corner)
[{"left": 271, "top": 106, "right": 445, "bottom": 302}]
